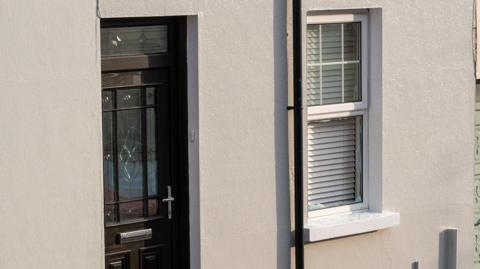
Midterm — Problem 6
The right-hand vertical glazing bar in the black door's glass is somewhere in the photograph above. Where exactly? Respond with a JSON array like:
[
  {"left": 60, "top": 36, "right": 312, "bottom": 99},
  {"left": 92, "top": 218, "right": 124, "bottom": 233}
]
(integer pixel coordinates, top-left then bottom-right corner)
[{"left": 140, "top": 87, "right": 148, "bottom": 217}]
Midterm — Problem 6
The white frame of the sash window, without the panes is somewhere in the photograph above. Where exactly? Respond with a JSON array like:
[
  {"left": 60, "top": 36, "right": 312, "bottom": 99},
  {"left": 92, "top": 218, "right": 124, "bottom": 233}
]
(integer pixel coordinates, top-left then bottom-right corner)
[{"left": 303, "top": 13, "right": 369, "bottom": 218}]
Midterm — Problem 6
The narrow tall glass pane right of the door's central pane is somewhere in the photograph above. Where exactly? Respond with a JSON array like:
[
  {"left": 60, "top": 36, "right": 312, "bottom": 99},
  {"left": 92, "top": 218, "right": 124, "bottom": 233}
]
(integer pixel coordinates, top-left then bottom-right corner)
[{"left": 146, "top": 107, "right": 158, "bottom": 195}]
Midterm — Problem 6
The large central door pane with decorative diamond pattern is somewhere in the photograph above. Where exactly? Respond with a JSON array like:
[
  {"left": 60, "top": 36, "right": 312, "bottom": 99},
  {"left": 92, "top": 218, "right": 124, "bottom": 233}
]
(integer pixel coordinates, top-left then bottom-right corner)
[{"left": 117, "top": 110, "right": 144, "bottom": 200}]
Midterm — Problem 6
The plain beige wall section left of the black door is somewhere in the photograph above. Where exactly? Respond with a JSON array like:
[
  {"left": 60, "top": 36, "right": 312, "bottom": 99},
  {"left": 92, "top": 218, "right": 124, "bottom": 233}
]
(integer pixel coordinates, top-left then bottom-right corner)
[{"left": 0, "top": 0, "right": 103, "bottom": 269}]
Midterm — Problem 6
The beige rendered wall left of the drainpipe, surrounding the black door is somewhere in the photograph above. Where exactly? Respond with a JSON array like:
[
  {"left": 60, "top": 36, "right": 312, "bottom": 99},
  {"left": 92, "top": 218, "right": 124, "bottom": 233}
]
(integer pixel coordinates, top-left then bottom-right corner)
[{"left": 0, "top": 0, "right": 289, "bottom": 269}]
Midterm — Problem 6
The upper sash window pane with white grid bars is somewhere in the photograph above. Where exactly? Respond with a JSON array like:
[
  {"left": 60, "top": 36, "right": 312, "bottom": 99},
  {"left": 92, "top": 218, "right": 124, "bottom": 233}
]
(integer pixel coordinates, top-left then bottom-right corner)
[{"left": 306, "top": 23, "right": 361, "bottom": 106}]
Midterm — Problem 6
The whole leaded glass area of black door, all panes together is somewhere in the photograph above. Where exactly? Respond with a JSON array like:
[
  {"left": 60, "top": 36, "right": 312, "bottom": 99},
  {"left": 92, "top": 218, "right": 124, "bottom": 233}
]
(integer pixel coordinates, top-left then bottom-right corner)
[{"left": 102, "top": 86, "right": 165, "bottom": 223}]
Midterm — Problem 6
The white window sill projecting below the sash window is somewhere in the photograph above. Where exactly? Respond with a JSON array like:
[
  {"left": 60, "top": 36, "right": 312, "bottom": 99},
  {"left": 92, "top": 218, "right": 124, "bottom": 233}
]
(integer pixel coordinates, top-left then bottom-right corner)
[{"left": 305, "top": 212, "right": 400, "bottom": 242}]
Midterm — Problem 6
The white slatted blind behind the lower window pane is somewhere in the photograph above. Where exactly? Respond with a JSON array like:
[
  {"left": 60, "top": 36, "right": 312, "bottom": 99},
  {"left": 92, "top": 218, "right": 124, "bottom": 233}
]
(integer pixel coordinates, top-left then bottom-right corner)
[{"left": 307, "top": 116, "right": 362, "bottom": 210}]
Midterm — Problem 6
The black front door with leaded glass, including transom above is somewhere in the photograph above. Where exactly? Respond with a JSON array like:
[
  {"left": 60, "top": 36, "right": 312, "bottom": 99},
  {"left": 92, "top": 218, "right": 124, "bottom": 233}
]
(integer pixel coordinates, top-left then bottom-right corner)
[{"left": 102, "top": 17, "right": 188, "bottom": 269}]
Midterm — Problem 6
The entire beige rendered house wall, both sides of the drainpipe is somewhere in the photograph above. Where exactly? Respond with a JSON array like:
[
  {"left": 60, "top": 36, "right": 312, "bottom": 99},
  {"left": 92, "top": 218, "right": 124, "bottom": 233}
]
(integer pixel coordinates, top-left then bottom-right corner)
[{"left": 0, "top": 0, "right": 474, "bottom": 269}]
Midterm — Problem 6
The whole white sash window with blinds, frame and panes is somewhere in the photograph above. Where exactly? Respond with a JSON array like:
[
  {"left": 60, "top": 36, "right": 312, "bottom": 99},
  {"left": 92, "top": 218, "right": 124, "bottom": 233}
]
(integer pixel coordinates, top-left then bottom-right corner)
[{"left": 304, "top": 14, "right": 368, "bottom": 217}]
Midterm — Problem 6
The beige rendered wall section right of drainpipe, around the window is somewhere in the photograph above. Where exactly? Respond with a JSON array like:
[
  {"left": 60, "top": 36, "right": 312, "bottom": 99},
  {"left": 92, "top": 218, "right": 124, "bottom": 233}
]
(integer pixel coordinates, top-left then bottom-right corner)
[{"left": 304, "top": 0, "right": 475, "bottom": 269}]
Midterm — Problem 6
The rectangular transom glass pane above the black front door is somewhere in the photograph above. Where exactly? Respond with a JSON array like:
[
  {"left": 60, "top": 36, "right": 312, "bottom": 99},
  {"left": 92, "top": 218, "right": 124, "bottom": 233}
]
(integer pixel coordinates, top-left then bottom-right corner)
[{"left": 102, "top": 25, "right": 168, "bottom": 57}]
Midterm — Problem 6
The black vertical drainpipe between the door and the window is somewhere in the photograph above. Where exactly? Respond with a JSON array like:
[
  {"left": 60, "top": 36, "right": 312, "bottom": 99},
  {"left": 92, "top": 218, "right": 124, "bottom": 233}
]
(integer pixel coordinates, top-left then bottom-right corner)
[{"left": 292, "top": 0, "right": 304, "bottom": 269}]
